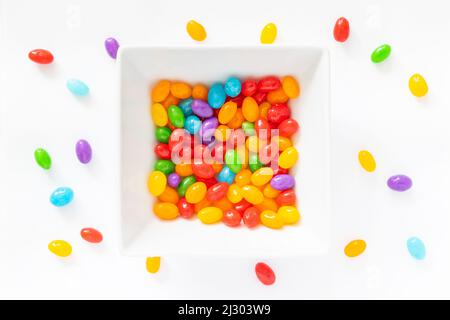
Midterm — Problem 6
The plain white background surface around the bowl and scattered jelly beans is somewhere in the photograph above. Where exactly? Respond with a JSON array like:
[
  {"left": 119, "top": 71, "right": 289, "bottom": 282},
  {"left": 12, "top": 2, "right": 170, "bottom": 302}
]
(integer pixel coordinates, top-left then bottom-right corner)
[{"left": 0, "top": 0, "right": 450, "bottom": 299}]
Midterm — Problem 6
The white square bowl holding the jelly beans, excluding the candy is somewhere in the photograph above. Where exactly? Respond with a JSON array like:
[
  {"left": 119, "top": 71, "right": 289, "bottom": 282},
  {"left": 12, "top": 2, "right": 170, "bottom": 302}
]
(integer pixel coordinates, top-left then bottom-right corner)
[{"left": 118, "top": 46, "right": 331, "bottom": 258}]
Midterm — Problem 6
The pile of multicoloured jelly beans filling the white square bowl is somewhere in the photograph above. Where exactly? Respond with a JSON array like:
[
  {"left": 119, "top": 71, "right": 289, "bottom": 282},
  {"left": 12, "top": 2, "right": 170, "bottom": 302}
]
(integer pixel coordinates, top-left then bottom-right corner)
[{"left": 148, "top": 76, "right": 300, "bottom": 229}]
